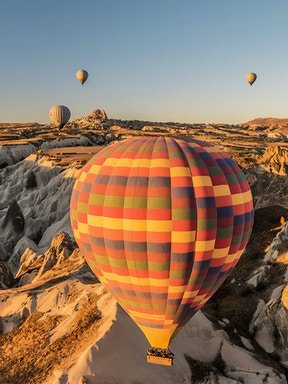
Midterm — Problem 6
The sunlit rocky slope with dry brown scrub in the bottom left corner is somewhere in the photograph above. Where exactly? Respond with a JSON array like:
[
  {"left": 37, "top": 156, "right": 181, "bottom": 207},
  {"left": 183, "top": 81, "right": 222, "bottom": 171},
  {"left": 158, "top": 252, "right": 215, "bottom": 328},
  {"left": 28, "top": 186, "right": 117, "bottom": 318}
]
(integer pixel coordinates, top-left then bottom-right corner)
[{"left": 0, "top": 270, "right": 116, "bottom": 384}]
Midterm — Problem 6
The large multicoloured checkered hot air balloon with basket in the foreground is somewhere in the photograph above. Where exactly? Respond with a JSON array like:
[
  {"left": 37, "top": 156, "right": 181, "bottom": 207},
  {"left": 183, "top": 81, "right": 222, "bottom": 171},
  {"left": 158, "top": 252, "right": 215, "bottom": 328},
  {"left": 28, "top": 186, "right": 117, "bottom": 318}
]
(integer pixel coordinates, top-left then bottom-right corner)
[{"left": 70, "top": 136, "right": 253, "bottom": 365}]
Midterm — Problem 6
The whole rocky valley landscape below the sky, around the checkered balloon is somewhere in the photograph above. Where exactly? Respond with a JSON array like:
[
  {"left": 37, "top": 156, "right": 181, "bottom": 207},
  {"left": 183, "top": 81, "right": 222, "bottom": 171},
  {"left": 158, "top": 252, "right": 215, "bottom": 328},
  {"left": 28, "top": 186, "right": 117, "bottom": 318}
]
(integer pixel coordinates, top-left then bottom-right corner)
[{"left": 0, "top": 110, "right": 288, "bottom": 384}]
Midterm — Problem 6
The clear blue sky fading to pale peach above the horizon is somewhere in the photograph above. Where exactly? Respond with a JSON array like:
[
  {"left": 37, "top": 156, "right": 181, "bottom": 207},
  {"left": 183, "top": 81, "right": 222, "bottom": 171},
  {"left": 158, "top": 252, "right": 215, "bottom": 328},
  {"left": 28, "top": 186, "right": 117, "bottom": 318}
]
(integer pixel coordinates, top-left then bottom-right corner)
[{"left": 0, "top": 0, "right": 288, "bottom": 123}]
